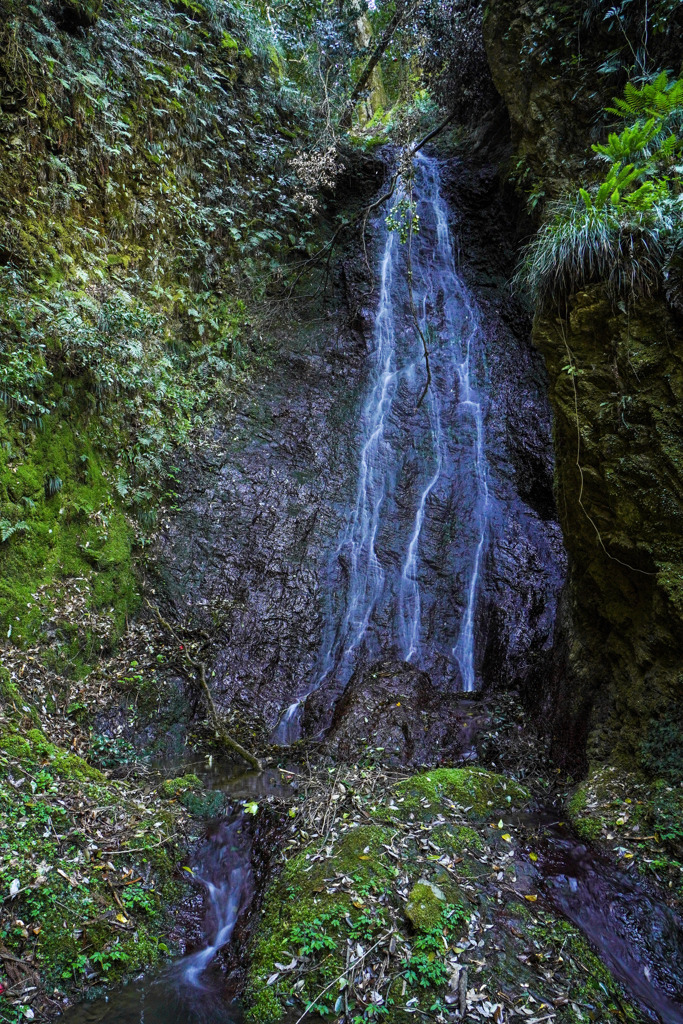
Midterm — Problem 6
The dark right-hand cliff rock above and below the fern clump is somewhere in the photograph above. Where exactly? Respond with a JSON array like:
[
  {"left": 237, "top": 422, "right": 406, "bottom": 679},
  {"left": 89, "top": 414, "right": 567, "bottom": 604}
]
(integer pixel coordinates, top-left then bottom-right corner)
[{"left": 484, "top": 0, "right": 683, "bottom": 761}]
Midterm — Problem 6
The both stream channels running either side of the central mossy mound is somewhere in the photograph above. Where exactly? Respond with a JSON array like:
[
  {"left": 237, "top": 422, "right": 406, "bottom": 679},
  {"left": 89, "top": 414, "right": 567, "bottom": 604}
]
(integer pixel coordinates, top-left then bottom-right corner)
[{"left": 60, "top": 772, "right": 683, "bottom": 1024}]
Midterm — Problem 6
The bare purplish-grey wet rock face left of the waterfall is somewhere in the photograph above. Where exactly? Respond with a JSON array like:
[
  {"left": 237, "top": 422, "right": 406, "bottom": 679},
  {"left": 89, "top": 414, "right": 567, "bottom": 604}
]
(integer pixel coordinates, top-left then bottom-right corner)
[{"left": 153, "top": 311, "right": 374, "bottom": 727}]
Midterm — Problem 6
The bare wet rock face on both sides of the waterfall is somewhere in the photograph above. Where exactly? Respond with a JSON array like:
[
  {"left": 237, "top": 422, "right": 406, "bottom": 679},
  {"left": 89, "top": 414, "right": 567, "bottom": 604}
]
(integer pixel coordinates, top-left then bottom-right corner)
[{"left": 157, "top": 153, "right": 564, "bottom": 737}]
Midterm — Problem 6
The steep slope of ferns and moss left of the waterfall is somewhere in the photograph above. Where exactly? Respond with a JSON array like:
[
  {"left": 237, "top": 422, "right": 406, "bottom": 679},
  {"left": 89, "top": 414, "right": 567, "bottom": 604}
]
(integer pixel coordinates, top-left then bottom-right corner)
[{"left": 0, "top": 0, "right": 374, "bottom": 647}]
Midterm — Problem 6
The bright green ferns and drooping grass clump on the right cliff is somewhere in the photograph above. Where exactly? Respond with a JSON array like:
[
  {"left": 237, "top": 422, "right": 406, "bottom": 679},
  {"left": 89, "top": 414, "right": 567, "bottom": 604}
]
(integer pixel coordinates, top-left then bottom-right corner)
[{"left": 517, "top": 73, "right": 683, "bottom": 303}]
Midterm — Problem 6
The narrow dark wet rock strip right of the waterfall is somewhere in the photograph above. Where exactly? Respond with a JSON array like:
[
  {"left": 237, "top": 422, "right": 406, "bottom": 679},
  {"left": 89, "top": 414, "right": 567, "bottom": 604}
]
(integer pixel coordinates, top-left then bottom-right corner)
[{"left": 446, "top": 159, "right": 566, "bottom": 711}]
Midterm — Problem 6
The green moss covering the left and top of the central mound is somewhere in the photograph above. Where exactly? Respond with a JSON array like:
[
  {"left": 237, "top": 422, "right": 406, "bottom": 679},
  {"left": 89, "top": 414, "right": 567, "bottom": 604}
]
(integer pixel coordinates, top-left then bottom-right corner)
[{"left": 246, "top": 768, "right": 529, "bottom": 1024}]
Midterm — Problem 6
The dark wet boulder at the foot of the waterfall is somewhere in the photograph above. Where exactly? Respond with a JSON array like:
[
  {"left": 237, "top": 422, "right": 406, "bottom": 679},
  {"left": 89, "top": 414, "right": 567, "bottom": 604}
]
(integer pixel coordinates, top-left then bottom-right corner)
[{"left": 311, "top": 662, "right": 486, "bottom": 766}]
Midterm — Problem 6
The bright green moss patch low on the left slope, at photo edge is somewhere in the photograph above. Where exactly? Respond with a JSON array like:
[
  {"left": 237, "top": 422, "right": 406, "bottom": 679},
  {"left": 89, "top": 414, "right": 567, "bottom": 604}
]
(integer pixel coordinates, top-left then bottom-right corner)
[{"left": 0, "top": 411, "right": 138, "bottom": 664}]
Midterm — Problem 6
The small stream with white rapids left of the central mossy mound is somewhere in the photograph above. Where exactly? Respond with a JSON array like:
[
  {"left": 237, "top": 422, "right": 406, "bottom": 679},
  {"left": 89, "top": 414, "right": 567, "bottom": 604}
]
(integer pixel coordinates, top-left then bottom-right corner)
[{"left": 60, "top": 818, "right": 252, "bottom": 1024}]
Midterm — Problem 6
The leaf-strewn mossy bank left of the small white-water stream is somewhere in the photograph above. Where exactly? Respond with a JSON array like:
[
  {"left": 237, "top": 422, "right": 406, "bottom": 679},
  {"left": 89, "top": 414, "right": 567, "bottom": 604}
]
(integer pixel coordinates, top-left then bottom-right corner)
[{"left": 0, "top": 602, "right": 259, "bottom": 1024}]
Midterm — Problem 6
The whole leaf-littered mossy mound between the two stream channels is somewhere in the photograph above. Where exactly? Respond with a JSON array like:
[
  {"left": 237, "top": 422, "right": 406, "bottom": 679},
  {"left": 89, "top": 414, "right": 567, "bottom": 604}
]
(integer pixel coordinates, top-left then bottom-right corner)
[{"left": 246, "top": 767, "right": 643, "bottom": 1024}]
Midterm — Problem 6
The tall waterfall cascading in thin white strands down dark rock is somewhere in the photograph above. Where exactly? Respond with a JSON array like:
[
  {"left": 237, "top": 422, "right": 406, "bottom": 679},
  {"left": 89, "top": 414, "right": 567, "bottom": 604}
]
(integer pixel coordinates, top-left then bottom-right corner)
[{"left": 272, "top": 155, "right": 493, "bottom": 744}]
